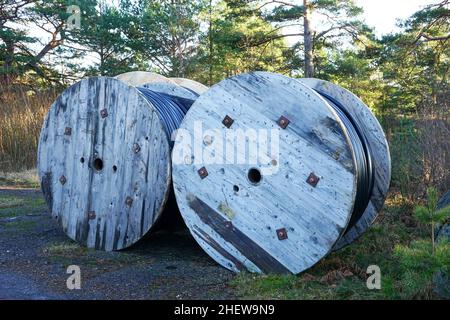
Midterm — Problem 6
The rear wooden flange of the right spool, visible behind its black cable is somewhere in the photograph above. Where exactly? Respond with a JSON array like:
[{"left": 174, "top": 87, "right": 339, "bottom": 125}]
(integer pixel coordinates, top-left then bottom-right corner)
[{"left": 298, "top": 79, "right": 391, "bottom": 250}]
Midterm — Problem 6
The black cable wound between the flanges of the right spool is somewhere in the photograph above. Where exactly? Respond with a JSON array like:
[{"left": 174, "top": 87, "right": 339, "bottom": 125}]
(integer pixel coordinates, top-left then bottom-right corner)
[{"left": 316, "top": 91, "right": 374, "bottom": 230}]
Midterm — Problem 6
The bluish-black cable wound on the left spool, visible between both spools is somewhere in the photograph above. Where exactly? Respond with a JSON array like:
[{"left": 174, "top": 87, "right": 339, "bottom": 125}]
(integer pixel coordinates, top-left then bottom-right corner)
[{"left": 137, "top": 87, "right": 194, "bottom": 138}]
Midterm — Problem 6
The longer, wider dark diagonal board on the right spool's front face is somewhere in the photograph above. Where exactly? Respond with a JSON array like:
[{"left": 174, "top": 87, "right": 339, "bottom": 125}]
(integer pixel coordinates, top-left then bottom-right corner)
[{"left": 187, "top": 194, "right": 292, "bottom": 274}]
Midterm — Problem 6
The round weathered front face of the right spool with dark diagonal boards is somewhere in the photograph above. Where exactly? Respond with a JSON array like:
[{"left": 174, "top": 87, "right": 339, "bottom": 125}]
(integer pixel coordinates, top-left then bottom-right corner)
[{"left": 172, "top": 72, "right": 390, "bottom": 274}]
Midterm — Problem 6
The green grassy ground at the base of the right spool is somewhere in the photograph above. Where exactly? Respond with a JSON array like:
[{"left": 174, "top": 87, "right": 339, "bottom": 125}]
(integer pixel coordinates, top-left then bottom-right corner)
[{"left": 232, "top": 193, "right": 450, "bottom": 299}]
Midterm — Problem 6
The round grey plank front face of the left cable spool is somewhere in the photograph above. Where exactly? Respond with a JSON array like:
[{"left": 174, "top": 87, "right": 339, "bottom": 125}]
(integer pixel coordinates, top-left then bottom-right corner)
[{"left": 38, "top": 77, "right": 171, "bottom": 251}]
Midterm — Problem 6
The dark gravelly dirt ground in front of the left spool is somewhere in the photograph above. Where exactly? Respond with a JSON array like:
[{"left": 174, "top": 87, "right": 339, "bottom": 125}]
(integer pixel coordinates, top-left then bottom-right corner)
[{"left": 0, "top": 187, "right": 236, "bottom": 299}]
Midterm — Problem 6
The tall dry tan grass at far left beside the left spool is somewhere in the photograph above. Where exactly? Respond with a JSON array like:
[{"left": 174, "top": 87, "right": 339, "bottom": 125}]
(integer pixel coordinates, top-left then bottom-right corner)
[{"left": 0, "top": 86, "right": 57, "bottom": 172}]
